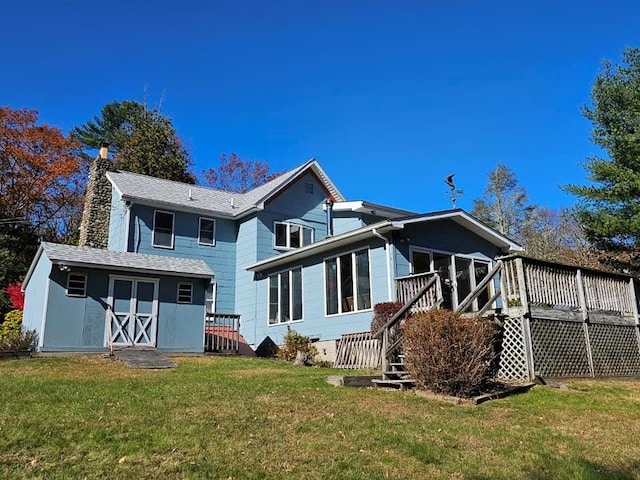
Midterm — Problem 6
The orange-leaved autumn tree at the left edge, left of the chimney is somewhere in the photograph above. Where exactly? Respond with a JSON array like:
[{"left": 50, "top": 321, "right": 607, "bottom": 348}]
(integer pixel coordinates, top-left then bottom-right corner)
[{"left": 0, "top": 107, "right": 85, "bottom": 236}]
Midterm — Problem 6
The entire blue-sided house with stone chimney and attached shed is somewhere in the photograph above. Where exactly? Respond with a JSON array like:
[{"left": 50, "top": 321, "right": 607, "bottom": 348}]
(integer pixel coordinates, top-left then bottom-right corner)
[{"left": 23, "top": 152, "right": 522, "bottom": 358}]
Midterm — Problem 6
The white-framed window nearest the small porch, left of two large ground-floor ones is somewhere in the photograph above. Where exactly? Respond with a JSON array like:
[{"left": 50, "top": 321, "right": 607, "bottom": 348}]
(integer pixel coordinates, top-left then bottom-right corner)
[{"left": 269, "top": 268, "right": 302, "bottom": 325}]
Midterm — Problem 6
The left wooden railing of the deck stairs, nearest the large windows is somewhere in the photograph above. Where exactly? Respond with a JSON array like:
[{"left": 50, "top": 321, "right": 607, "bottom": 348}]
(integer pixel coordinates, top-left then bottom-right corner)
[{"left": 373, "top": 272, "right": 443, "bottom": 375}]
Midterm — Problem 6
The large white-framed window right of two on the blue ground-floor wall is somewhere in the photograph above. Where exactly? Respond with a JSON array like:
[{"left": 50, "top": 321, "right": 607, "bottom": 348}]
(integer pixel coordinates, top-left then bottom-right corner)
[{"left": 324, "top": 249, "right": 371, "bottom": 315}]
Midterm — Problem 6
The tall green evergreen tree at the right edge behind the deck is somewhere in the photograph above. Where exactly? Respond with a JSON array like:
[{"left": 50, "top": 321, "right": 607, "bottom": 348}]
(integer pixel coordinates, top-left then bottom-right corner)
[{"left": 566, "top": 48, "right": 640, "bottom": 274}]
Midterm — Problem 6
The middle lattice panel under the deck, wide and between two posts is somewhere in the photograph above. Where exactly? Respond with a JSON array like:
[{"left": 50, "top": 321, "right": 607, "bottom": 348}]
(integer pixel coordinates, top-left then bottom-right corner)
[{"left": 530, "top": 319, "right": 591, "bottom": 377}]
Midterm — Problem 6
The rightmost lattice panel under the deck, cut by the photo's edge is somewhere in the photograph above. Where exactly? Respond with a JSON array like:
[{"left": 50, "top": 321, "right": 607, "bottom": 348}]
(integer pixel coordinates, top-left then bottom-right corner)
[{"left": 589, "top": 324, "right": 640, "bottom": 377}]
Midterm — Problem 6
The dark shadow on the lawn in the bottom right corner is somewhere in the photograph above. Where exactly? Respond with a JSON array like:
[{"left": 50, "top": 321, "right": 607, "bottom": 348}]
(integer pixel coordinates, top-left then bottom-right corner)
[{"left": 468, "top": 459, "right": 640, "bottom": 480}]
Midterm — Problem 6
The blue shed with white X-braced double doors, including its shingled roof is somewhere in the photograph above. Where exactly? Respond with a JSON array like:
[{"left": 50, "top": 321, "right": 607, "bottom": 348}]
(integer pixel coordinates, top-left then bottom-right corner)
[{"left": 23, "top": 243, "right": 214, "bottom": 352}]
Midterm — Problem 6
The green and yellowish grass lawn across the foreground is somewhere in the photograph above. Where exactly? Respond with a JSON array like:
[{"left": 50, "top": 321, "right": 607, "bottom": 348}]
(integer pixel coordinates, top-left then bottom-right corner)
[{"left": 0, "top": 356, "right": 640, "bottom": 480}]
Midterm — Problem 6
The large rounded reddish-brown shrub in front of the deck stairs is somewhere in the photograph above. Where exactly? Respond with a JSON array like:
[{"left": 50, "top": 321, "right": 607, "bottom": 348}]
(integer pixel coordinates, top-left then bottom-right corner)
[{"left": 404, "top": 309, "right": 497, "bottom": 397}]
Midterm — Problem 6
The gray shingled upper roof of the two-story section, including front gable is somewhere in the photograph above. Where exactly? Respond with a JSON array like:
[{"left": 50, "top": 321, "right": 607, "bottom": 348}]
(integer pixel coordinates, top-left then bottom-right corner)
[{"left": 107, "top": 160, "right": 344, "bottom": 217}]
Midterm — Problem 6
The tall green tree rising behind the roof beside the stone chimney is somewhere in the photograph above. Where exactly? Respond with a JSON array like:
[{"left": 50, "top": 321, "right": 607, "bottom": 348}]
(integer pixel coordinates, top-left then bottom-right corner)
[{"left": 71, "top": 100, "right": 195, "bottom": 183}]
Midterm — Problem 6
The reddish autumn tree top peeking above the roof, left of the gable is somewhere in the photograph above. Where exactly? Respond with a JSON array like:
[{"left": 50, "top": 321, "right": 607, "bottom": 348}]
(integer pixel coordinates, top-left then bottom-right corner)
[{"left": 202, "top": 152, "right": 280, "bottom": 193}]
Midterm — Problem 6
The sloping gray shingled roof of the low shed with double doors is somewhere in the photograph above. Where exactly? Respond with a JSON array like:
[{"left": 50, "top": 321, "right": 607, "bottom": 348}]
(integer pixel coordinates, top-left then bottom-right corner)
[{"left": 40, "top": 242, "right": 214, "bottom": 278}]
